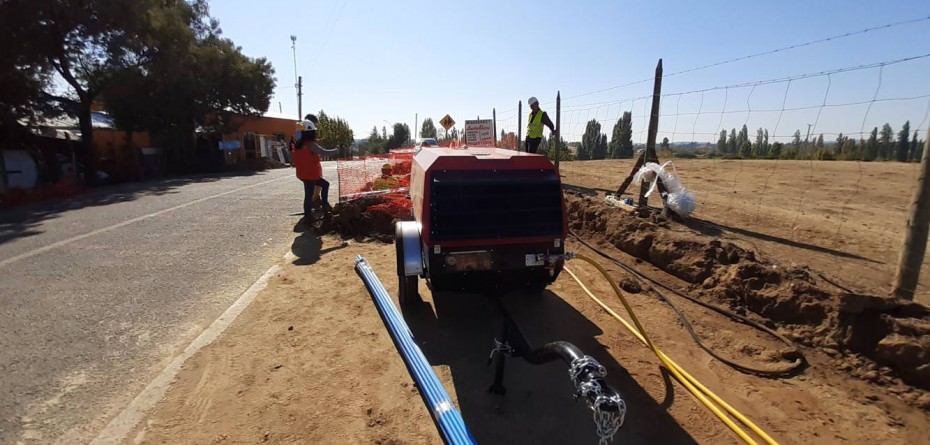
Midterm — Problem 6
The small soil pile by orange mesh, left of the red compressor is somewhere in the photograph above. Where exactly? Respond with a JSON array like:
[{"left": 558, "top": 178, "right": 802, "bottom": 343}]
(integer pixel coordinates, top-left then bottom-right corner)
[{"left": 320, "top": 195, "right": 413, "bottom": 243}]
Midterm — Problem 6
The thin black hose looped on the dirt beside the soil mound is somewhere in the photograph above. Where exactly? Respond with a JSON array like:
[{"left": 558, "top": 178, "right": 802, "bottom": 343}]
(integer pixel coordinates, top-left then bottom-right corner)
[{"left": 569, "top": 230, "right": 807, "bottom": 378}]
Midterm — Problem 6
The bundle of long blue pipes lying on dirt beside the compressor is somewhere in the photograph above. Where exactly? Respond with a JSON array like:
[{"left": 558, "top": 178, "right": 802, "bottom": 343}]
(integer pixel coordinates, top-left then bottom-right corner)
[{"left": 355, "top": 255, "right": 477, "bottom": 445}]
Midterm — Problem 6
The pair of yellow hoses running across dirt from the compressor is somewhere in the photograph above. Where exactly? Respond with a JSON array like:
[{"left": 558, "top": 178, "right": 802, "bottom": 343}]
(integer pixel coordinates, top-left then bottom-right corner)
[{"left": 565, "top": 255, "right": 778, "bottom": 445}]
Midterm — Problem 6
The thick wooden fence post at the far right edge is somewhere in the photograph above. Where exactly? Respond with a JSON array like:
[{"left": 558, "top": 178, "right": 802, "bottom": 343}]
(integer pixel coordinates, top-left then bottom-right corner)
[{"left": 891, "top": 129, "right": 930, "bottom": 300}]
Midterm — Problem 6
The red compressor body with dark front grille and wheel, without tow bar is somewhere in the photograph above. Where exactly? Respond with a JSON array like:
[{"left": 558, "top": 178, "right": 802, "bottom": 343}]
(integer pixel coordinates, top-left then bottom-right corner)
[{"left": 395, "top": 147, "right": 568, "bottom": 306}]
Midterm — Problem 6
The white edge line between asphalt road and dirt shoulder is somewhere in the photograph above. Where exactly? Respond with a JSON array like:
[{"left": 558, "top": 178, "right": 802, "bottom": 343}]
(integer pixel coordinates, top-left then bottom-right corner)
[{"left": 90, "top": 265, "right": 281, "bottom": 445}]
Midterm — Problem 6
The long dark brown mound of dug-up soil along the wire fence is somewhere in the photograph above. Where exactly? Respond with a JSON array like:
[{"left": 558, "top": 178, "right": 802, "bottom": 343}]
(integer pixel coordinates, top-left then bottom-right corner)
[{"left": 566, "top": 196, "right": 930, "bottom": 396}]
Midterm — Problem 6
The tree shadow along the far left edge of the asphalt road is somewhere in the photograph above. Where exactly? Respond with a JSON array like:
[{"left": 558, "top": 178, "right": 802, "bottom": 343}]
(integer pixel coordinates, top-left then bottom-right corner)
[{"left": 0, "top": 171, "right": 258, "bottom": 244}]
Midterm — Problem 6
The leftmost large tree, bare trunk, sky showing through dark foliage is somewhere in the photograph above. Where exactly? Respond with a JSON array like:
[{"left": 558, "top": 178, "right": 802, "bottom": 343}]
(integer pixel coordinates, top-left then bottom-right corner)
[{"left": 0, "top": 0, "right": 181, "bottom": 183}]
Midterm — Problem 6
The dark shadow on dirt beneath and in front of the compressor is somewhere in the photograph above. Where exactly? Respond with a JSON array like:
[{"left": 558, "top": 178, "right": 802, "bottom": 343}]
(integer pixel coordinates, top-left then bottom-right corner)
[{"left": 404, "top": 291, "right": 696, "bottom": 444}]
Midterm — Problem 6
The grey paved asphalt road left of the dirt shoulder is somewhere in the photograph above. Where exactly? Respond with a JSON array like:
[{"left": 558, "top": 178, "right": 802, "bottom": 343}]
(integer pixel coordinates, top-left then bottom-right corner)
[{"left": 0, "top": 163, "right": 338, "bottom": 445}]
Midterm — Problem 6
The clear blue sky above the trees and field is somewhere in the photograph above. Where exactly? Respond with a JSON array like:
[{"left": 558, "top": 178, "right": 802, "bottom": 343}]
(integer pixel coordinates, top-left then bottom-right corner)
[{"left": 211, "top": 0, "right": 930, "bottom": 142}]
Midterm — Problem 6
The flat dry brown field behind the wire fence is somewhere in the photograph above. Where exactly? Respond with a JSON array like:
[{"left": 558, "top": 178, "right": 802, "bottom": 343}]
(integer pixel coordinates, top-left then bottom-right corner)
[{"left": 562, "top": 159, "right": 930, "bottom": 304}]
